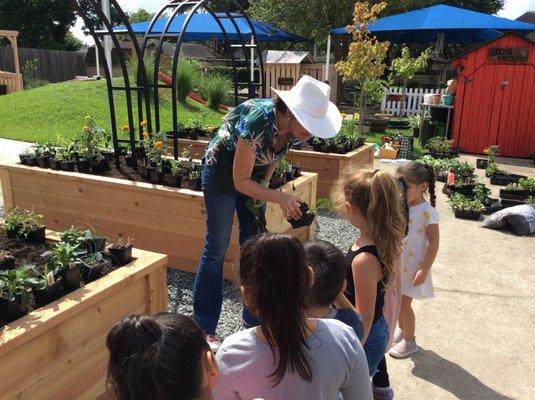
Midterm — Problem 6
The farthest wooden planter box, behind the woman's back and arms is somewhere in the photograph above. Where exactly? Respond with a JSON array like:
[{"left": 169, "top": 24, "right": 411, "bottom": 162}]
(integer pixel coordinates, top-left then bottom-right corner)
[{"left": 169, "top": 139, "right": 374, "bottom": 197}]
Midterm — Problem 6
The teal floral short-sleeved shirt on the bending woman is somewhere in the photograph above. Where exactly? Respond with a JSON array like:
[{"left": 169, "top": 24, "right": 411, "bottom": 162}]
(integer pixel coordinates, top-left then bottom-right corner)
[{"left": 205, "top": 99, "right": 292, "bottom": 166}]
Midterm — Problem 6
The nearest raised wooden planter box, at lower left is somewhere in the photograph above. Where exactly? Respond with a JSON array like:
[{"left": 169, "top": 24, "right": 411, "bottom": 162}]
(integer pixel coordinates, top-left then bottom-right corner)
[{"left": 0, "top": 230, "right": 167, "bottom": 400}]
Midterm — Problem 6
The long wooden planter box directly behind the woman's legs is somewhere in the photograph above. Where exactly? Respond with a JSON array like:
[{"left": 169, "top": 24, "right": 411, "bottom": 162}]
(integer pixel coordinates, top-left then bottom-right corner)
[{"left": 0, "top": 164, "right": 317, "bottom": 279}]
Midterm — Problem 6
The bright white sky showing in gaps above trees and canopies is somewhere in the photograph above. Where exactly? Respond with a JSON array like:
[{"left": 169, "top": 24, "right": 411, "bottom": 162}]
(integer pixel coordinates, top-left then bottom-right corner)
[{"left": 71, "top": 0, "right": 535, "bottom": 45}]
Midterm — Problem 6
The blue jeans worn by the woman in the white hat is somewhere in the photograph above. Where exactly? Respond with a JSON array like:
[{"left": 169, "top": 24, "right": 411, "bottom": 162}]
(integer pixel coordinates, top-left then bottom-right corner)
[{"left": 193, "top": 165, "right": 255, "bottom": 335}]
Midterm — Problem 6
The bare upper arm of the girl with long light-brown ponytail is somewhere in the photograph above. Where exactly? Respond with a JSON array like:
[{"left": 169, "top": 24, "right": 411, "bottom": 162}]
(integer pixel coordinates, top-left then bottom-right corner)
[{"left": 351, "top": 253, "right": 381, "bottom": 344}]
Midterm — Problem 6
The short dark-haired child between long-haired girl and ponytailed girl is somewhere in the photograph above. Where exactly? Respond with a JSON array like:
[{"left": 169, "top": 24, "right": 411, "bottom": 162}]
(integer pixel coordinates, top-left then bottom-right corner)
[{"left": 305, "top": 240, "right": 364, "bottom": 340}]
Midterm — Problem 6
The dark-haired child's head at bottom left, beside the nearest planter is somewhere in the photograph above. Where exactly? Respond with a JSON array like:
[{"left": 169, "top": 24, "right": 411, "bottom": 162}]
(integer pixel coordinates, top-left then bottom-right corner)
[{"left": 106, "top": 313, "right": 219, "bottom": 400}]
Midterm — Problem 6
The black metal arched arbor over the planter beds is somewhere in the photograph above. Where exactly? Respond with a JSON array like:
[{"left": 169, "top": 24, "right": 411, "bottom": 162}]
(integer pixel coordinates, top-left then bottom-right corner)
[{"left": 71, "top": 0, "right": 265, "bottom": 168}]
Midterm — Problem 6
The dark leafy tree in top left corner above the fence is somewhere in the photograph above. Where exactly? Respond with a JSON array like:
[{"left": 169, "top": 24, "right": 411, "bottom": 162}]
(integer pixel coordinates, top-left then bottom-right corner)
[{"left": 0, "top": 0, "right": 76, "bottom": 50}]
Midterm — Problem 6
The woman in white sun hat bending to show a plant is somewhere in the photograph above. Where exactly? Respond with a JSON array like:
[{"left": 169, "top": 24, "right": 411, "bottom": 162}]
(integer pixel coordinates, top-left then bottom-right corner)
[{"left": 193, "top": 75, "right": 342, "bottom": 350}]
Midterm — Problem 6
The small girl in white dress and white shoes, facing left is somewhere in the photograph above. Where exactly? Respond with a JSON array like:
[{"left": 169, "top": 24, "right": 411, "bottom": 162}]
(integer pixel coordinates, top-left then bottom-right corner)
[{"left": 389, "top": 161, "right": 439, "bottom": 358}]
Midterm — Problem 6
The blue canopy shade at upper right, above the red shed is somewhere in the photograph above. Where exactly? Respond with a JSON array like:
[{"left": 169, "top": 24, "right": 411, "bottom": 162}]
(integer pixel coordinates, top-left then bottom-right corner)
[{"left": 330, "top": 5, "right": 535, "bottom": 42}]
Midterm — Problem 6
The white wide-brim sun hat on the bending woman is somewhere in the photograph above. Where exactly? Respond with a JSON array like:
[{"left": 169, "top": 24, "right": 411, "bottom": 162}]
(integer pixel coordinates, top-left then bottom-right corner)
[{"left": 271, "top": 75, "right": 342, "bottom": 139}]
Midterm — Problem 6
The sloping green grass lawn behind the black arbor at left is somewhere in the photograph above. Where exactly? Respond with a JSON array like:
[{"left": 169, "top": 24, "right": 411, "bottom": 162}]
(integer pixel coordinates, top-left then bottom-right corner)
[{"left": 0, "top": 80, "right": 224, "bottom": 142}]
